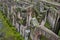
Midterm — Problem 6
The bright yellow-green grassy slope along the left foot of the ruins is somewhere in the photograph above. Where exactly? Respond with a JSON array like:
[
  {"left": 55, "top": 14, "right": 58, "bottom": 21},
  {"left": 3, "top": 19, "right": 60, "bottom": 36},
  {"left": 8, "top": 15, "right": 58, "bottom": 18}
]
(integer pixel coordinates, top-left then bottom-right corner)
[{"left": 0, "top": 11, "right": 24, "bottom": 40}]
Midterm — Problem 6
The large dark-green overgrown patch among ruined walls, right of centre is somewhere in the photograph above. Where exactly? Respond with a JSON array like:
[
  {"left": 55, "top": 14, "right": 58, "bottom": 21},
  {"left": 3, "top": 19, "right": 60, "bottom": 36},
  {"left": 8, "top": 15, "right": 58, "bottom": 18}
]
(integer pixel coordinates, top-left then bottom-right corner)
[{"left": 33, "top": 6, "right": 46, "bottom": 23}]
